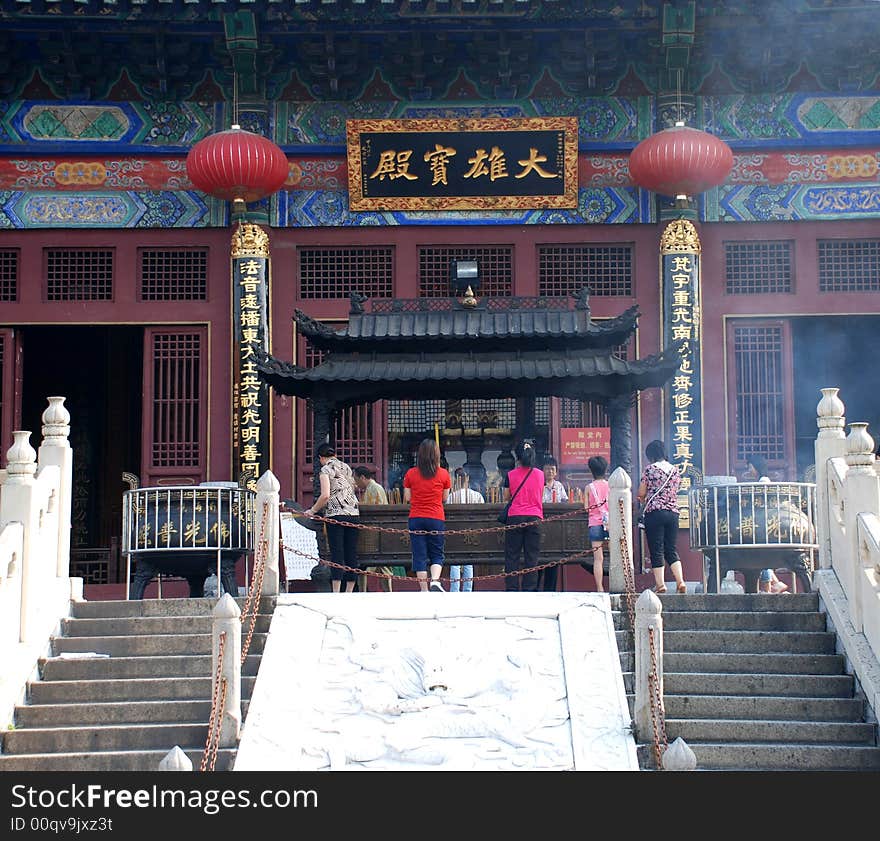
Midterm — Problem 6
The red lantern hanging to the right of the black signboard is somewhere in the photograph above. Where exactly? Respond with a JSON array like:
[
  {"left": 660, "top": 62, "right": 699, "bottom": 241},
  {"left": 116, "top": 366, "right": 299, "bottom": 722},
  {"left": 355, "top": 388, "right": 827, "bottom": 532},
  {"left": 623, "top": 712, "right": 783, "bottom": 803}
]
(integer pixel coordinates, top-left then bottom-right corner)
[{"left": 629, "top": 123, "right": 733, "bottom": 196}]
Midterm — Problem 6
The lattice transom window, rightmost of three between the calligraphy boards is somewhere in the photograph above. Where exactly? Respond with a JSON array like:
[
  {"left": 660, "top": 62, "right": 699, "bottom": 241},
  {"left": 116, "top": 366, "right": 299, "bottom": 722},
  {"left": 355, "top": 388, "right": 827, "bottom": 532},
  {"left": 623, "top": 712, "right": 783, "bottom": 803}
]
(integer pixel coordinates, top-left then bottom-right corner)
[{"left": 538, "top": 243, "right": 633, "bottom": 296}]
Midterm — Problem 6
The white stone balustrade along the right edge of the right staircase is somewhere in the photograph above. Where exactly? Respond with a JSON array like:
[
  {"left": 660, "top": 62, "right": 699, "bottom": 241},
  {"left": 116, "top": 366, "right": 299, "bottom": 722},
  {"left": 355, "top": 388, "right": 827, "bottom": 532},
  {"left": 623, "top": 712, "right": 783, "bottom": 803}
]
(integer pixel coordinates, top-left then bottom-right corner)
[{"left": 814, "top": 388, "right": 880, "bottom": 714}]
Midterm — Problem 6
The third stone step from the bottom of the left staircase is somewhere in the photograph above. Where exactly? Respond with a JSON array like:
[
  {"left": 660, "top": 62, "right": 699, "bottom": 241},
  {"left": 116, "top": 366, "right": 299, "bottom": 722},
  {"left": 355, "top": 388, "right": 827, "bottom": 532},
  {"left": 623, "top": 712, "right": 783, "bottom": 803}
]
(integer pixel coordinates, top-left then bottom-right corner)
[{"left": 15, "top": 695, "right": 211, "bottom": 728}]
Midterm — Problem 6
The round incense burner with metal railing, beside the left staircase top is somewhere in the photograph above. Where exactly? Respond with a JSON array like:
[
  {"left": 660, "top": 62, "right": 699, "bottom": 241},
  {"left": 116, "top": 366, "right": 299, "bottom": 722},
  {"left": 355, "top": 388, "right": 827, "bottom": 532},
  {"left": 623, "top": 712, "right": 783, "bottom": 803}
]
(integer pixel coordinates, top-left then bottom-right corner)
[{"left": 122, "top": 482, "right": 256, "bottom": 599}]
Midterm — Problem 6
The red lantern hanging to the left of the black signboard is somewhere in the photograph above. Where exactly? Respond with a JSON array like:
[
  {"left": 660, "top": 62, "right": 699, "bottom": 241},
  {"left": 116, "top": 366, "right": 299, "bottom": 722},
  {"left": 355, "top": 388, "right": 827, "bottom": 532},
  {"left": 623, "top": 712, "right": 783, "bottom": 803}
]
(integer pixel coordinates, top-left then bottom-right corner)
[{"left": 186, "top": 126, "right": 288, "bottom": 202}]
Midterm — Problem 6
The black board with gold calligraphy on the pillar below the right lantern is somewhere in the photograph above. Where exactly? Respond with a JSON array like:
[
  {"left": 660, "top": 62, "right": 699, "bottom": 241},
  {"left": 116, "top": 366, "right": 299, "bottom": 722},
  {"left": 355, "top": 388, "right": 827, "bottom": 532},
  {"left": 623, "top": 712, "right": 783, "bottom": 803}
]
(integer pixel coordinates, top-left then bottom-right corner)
[{"left": 660, "top": 219, "right": 703, "bottom": 526}]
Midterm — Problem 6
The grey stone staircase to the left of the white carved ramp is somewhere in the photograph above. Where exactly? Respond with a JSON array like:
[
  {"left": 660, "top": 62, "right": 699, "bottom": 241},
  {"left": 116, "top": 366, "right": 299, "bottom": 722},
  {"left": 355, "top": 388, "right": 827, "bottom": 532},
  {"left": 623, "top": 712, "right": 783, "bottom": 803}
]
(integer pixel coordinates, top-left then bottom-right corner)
[{"left": 0, "top": 598, "right": 274, "bottom": 771}]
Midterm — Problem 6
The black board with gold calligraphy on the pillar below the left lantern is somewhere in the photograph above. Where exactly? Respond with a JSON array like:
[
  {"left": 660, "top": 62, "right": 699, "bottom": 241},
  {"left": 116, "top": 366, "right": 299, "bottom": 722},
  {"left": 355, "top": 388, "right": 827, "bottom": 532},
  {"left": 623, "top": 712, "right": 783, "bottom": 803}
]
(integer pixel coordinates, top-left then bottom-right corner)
[{"left": 232, "top": 223, "right": 272, "bottom": 489}]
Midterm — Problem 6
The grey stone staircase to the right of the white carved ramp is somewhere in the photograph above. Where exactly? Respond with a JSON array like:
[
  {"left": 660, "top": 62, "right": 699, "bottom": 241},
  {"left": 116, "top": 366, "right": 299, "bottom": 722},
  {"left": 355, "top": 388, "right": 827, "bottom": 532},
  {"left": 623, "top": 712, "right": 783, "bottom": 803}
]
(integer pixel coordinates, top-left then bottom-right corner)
[{"left": 612, "top": 593, "right": 880, "bottom": 771}]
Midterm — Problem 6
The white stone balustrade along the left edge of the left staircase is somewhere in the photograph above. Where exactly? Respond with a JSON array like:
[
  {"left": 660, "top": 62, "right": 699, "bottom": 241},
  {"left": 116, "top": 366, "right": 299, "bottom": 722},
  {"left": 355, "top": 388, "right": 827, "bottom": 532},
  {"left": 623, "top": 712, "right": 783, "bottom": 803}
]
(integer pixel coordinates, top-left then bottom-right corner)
[{"left": 0, "top": 397, "right": 82, "bottom": 725}]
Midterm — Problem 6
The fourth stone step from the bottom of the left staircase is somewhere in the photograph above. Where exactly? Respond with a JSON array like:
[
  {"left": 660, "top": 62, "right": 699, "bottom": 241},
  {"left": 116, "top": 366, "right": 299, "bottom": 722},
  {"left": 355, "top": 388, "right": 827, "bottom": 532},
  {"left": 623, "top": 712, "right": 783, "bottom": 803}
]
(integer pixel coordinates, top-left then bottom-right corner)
[{"left": 28, "top": 676, "right": 256, "bottom": 705}]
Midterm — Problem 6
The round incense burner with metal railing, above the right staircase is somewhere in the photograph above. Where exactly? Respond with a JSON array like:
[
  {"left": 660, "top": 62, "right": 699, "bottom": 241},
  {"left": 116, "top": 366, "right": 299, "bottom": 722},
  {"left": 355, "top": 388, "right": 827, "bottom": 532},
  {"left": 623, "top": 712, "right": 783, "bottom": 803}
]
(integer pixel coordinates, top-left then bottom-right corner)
[{"left": 688, "top": 482, "right": 819, "bottom": 592}]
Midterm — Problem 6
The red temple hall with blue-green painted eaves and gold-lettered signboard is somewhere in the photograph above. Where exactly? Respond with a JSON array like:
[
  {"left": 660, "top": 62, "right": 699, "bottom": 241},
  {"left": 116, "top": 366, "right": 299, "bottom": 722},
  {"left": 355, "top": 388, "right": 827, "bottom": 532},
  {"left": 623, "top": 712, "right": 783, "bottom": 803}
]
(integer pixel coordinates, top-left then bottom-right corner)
[{"left": 0, "top": 0, "right": 880, "bottom": 583}]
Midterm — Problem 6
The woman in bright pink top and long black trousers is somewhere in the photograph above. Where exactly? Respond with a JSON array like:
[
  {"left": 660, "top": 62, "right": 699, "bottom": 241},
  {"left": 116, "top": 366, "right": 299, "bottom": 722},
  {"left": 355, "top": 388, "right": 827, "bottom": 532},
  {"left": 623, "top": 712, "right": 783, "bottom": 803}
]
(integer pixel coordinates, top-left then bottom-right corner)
[{"left": 503, "top": 441, "right": 544, "bottom": 593}]
